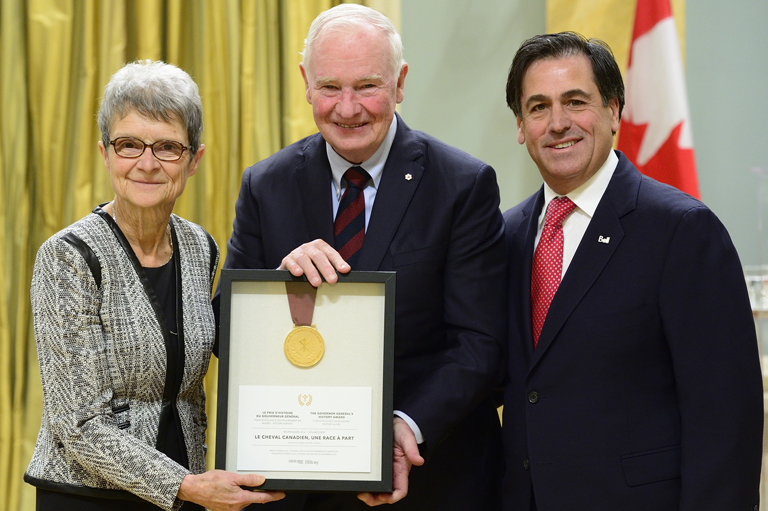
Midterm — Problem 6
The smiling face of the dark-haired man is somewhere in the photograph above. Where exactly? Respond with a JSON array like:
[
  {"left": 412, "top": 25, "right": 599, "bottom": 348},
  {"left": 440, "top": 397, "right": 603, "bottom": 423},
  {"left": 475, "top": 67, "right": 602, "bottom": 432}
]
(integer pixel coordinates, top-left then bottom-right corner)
[{"left": 517, "top": 54, "right": 619, "bottom": 195}]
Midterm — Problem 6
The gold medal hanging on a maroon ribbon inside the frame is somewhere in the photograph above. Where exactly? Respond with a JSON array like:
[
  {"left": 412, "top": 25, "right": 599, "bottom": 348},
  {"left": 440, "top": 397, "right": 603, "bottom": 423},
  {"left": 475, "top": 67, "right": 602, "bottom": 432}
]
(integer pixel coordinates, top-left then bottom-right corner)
[{"left": 283, "top": 282, "right": 325, "bottom": 368}]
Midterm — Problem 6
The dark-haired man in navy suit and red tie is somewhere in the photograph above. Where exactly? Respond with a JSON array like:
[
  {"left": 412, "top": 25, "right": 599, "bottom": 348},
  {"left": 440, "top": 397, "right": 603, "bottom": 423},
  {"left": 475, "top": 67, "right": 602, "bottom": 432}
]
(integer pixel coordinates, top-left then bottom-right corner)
[{"left": 503, "top": 33, "right": 763, "bottom": 511}]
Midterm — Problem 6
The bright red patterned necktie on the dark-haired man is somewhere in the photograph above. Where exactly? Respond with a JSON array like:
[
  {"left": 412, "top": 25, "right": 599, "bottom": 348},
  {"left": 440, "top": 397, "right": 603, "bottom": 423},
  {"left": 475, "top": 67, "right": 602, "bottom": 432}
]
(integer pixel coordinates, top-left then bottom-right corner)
[{"left": 531, "top": 197, "right": 576, "bottom": 348}]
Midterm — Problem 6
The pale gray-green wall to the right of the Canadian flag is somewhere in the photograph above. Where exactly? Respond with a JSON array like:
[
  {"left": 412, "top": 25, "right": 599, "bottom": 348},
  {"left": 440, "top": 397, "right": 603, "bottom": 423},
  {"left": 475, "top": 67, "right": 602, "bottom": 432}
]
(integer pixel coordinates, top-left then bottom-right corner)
[{"left": 685, "top": 0, "right": 768, "bottom": 265}]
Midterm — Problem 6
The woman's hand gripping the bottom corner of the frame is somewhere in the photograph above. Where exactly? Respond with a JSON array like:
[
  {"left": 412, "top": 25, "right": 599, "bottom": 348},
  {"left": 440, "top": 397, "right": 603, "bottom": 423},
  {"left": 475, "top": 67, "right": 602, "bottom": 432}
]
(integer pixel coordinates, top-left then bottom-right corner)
[{"left": 177, "top": 470, "right": 285, "bottom": 511}]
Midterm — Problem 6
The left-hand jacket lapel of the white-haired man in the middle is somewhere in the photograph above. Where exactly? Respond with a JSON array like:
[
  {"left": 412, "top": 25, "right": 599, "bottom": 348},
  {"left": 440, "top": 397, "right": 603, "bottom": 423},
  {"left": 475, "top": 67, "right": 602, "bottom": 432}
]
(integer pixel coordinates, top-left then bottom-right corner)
[{"left": 294, "top": 135, "right": 333, "bottom": 246}]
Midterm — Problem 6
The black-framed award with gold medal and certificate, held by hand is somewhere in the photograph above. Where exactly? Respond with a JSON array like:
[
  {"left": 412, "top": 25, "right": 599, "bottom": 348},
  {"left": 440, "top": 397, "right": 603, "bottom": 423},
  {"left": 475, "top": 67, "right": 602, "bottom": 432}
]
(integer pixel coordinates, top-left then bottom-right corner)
[{"left": 216, "top": 269, "right": 395, "bottom": 492}]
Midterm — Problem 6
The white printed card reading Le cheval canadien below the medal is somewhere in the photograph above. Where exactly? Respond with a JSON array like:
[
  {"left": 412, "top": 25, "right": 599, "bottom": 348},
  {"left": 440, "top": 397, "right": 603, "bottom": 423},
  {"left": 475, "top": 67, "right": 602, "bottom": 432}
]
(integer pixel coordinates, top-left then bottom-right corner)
[{"left": 237, "top": 385, "right": 371, "bottom": 472}]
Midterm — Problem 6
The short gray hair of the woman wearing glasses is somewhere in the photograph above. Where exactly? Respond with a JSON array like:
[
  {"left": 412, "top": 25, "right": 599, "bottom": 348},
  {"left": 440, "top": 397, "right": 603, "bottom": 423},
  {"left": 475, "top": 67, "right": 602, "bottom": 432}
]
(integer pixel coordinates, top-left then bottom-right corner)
[{"left": 99, "top": 60, "right": 203, "bottom": 155}]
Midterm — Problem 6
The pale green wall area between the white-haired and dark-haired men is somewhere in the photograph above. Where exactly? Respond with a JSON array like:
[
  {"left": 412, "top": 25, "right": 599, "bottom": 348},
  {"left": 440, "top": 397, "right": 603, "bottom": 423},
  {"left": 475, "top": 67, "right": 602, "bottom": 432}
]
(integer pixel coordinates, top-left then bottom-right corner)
[{"left": 400, "top": 0, "right": 546, "bottom": 210}]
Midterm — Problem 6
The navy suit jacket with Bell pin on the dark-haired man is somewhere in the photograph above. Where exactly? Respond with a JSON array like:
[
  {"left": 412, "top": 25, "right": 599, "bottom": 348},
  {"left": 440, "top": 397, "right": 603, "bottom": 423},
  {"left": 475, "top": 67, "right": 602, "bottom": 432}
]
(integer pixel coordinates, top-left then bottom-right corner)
[{"left": 503, "top": 152, "right": 763, "bottom": 511}]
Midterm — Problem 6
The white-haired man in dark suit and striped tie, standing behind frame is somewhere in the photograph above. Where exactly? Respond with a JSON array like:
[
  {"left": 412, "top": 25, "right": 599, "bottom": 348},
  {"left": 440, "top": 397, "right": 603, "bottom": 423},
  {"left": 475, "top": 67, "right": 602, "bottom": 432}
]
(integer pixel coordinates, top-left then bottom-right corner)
[{"left": 216, "top": 4, "right": 506, "bottom": 511}]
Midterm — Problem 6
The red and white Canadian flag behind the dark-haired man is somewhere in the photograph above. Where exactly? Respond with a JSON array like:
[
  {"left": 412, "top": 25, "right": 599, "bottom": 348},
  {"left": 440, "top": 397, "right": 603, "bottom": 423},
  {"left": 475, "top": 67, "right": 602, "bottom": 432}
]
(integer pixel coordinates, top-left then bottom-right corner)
[{"left": 618, "top": 0, "right": 699, "bottom": 198}]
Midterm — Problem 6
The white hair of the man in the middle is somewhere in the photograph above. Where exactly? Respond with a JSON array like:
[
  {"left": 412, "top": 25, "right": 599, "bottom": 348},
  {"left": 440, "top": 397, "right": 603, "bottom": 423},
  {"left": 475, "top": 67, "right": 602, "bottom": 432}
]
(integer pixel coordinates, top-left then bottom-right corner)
[{"left": 301, "top": 4, "right": 405, "bottom": 78}]
